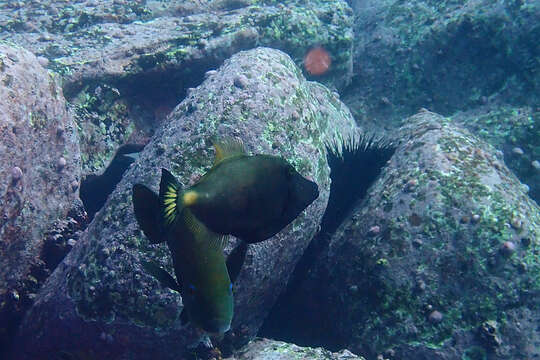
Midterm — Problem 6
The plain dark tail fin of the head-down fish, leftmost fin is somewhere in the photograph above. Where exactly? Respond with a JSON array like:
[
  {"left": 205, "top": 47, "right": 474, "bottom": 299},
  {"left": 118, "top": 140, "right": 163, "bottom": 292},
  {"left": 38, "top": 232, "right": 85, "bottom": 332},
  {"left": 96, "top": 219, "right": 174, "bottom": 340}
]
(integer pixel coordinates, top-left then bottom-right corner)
[{"left": 132, "top": 184, "right": 165, "bottom": 244}]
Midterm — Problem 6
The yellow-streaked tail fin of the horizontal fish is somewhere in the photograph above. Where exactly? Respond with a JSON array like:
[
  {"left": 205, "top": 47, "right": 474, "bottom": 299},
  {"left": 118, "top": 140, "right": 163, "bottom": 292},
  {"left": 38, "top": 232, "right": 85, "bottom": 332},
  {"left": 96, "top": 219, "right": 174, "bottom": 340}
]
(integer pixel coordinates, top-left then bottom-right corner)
[{"left": 159, "top": 169, "right": 181, "bottom": 230}]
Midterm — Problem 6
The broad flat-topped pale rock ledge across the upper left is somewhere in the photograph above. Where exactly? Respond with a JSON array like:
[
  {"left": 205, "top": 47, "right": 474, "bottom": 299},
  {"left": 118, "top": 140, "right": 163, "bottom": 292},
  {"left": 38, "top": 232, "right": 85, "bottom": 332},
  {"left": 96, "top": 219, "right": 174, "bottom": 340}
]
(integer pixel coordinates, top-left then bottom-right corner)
[{"left": 0, "top": 0, "right": 353, "bottom": 87}]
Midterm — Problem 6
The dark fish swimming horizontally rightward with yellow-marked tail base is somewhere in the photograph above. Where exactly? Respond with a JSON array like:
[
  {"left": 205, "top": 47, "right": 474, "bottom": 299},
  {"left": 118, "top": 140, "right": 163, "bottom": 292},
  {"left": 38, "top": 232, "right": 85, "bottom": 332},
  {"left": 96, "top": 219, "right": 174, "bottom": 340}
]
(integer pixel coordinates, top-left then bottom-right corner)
[{"left": 170, "top": 139, "right": 319, "bottom": 243}]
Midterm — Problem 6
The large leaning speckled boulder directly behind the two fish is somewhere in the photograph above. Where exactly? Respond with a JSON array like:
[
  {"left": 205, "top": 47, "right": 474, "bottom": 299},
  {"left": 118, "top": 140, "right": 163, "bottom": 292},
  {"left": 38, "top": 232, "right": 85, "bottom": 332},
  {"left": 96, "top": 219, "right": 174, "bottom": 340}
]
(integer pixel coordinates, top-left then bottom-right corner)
[{"left": 11, "top": 48, "right": 355, "bottom": 359}]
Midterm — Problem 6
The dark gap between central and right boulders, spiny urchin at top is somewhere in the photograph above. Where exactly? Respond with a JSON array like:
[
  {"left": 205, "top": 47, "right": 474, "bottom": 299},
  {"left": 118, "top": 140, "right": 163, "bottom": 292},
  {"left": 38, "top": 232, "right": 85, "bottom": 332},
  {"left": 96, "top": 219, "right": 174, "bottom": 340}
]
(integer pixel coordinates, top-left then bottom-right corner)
[{"left": 258, "top": 136, "right": 395, "bottom": 351}]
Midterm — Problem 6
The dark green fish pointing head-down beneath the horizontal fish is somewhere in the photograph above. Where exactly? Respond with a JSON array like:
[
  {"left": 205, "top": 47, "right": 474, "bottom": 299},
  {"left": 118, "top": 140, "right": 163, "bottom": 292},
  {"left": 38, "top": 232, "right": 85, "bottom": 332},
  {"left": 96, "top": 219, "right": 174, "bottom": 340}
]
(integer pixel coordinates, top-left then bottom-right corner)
[{"left": 133, "top": 180, "right": 234, "bottom": 334}]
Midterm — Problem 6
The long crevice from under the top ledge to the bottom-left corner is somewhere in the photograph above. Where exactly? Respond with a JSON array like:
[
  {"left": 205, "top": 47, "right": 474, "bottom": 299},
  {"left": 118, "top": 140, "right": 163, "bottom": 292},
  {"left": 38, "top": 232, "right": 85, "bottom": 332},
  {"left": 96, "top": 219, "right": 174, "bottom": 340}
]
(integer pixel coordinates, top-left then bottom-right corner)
[{"left": 0, "top": 58, "right": 221, "bottom": 358}]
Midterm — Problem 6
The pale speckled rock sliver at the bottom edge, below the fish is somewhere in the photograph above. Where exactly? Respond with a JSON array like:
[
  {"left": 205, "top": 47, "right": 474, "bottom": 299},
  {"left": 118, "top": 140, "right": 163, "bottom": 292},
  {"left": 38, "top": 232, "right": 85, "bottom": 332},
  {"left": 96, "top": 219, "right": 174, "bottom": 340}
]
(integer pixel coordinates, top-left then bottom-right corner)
[{"left": 225, "top": 338, "right": 364, "bottom": 360}]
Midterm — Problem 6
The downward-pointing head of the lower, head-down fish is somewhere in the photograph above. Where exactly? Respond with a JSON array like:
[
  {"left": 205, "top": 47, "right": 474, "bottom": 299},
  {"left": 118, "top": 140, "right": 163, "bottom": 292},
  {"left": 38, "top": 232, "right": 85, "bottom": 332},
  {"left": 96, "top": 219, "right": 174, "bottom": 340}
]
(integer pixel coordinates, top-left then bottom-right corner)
[{"left": 186, "top": 283, "right": 233, "bottom": 335}]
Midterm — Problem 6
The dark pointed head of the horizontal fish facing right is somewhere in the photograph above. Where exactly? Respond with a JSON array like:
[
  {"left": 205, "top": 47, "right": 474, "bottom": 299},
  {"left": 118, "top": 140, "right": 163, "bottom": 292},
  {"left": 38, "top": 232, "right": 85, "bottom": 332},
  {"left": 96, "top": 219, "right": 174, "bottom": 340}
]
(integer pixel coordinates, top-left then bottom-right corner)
[{"left": 283, "top": 165, "right": 319, "bottom": 221}]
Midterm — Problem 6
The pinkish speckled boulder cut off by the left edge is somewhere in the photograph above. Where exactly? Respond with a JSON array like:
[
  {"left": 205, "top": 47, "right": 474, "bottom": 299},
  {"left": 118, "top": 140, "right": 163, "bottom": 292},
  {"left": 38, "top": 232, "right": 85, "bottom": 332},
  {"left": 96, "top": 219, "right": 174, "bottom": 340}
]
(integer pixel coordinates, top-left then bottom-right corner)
[{"left": 0, "top": 44, "right": 80, "bottom": 348}]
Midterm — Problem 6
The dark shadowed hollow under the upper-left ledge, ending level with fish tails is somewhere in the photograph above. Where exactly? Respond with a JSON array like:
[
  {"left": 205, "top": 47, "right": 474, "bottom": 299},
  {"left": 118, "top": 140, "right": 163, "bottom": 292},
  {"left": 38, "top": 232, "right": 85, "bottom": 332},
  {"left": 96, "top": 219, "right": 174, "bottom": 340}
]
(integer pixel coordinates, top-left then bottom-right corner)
[{"left": 75, "top": 58, "right": 221, "bottom": 221}]
